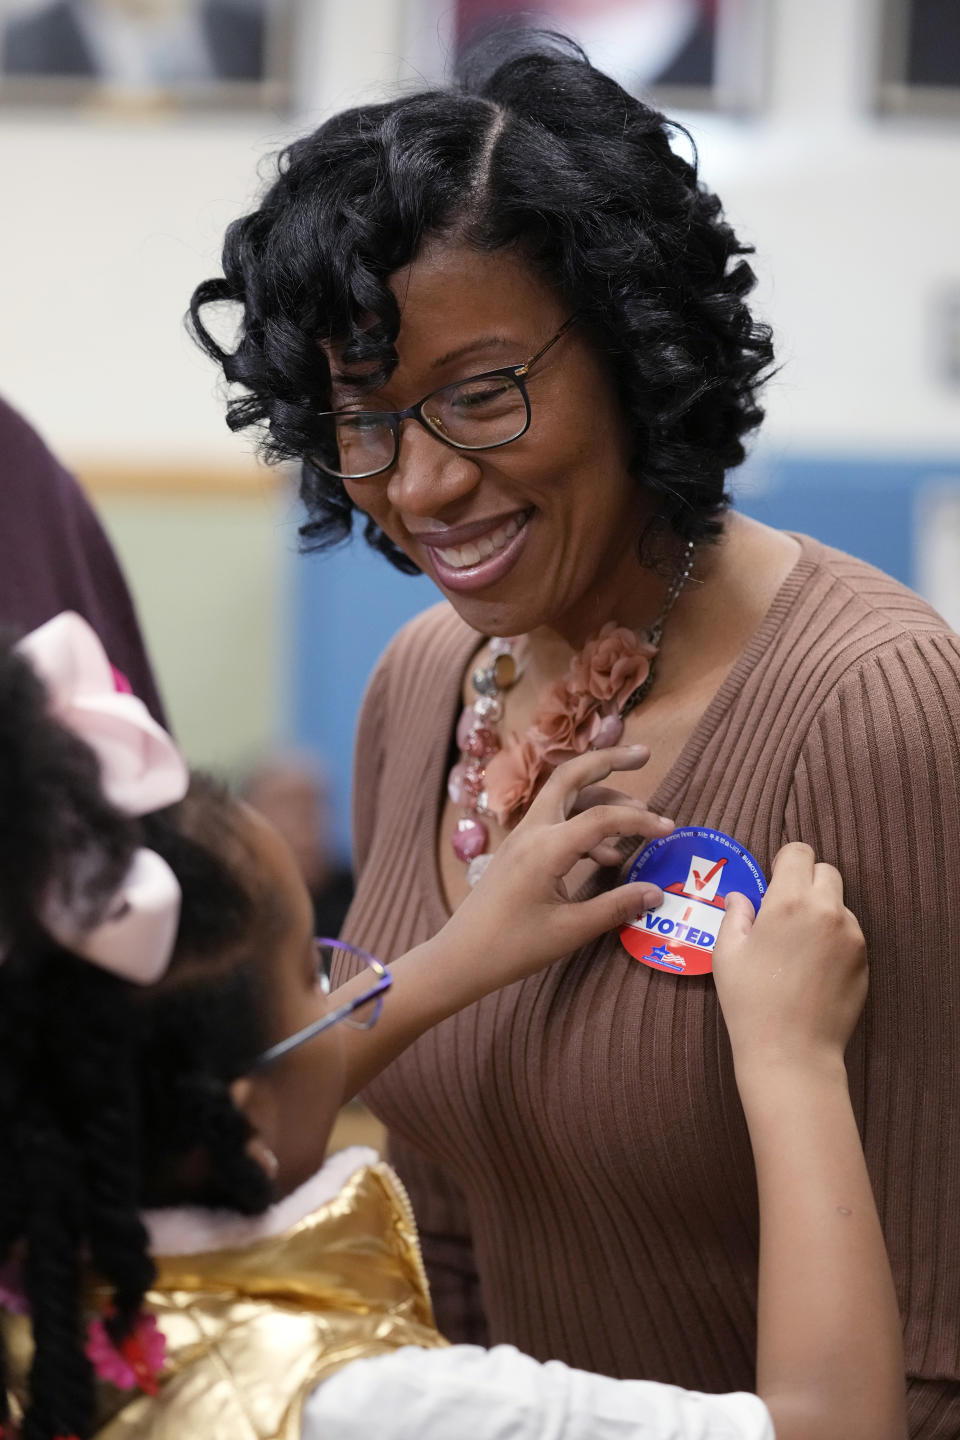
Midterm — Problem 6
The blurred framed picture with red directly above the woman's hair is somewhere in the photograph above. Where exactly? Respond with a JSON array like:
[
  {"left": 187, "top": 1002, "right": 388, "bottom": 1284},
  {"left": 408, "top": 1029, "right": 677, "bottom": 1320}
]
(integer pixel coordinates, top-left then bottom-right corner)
[{"left": 413, "top": 0, "right": 770, "bottom": 112}]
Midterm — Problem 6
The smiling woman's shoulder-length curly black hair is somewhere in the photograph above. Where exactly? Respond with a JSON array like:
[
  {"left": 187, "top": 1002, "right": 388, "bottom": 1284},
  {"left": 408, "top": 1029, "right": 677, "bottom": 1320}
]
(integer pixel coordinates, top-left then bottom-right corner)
[{"left": 190, "top": 30, "right": 773, "bottom": 573}]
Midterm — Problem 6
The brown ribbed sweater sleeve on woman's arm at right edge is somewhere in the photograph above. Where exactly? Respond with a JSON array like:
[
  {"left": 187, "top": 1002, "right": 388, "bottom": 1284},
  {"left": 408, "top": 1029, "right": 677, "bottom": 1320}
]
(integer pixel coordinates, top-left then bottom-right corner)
[{"left": 782, "top": 632, "right": 960, "bottom": 1440}]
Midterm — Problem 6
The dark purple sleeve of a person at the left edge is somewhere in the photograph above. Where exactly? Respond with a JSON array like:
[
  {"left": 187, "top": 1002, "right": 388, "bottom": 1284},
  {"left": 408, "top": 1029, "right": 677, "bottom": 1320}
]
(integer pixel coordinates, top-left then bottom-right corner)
[{"left": 0, "top": 399, "right": 166, "bottom": 724}]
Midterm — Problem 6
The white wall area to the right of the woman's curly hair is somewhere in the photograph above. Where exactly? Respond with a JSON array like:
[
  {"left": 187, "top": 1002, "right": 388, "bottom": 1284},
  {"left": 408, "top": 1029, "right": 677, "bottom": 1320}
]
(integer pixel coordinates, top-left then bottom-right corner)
[{"left": 679, "top": 0, "right": 960, "bottom": 455}]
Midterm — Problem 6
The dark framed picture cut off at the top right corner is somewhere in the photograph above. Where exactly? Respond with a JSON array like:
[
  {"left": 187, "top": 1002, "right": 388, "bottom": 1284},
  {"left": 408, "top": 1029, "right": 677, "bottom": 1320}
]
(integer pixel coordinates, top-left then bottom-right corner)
[{"left": 878, "top": 0, "right": 960, "bottom": 115}]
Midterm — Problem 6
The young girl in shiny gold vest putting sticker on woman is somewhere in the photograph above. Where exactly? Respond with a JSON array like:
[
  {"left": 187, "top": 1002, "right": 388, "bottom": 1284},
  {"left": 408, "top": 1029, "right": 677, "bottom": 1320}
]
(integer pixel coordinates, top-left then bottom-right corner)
[{"left": 0, "top": 616, "right": 904, "bottom": 1440}]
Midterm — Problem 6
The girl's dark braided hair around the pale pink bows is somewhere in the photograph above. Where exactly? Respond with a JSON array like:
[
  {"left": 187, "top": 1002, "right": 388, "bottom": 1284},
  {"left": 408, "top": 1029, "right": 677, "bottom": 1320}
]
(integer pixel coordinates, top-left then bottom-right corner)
[{"left": 0, "top": 639, "right": 282, "bottom": 1440}]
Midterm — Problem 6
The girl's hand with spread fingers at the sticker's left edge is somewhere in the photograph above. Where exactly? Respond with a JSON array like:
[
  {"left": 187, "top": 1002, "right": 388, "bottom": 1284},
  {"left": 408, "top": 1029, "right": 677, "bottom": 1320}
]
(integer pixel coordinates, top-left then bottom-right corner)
[{"left": 446, "top": 746, "right": 674, "bottom": 985}]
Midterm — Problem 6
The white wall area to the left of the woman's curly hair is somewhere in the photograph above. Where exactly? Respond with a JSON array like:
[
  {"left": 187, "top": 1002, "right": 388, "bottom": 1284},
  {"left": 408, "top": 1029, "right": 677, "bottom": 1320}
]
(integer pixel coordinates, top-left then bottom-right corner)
[{"left": 0, "top": 0, "right": 400, "bottom": 467}]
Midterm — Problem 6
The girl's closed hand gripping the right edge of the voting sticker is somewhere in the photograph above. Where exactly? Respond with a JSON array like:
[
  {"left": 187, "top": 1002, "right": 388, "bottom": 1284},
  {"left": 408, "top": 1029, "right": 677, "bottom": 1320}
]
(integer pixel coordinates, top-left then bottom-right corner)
[{"left": 714, "top": 844, "right": 866, "bottom": 1076}]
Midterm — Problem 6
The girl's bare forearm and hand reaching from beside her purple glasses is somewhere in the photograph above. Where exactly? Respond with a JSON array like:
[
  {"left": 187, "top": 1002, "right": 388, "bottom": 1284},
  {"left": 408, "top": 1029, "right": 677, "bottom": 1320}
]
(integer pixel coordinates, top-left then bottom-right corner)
[{"left": 335, "top": 746, "right": 674, "bottom": 1100}]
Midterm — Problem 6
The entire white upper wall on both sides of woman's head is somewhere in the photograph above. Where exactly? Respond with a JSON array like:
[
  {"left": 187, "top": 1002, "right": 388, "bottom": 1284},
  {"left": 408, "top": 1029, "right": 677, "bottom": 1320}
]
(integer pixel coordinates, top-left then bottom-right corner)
[{"left": 0, "top": 0, "right": 960, "bottom": 464}]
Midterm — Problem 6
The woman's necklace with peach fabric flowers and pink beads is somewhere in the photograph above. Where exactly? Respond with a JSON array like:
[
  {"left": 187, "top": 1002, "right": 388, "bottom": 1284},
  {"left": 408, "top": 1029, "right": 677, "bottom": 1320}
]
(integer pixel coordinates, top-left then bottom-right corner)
[{"left": 446, "top": 540, "right": 695, "bottom": 886}]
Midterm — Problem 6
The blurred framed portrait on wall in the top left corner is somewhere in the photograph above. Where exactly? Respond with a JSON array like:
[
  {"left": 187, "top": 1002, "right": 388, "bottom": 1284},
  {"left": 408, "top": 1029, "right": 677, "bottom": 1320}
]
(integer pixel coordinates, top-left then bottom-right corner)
[{"left": 0, "top": 0, "right": 294, "bottom": 111}]
